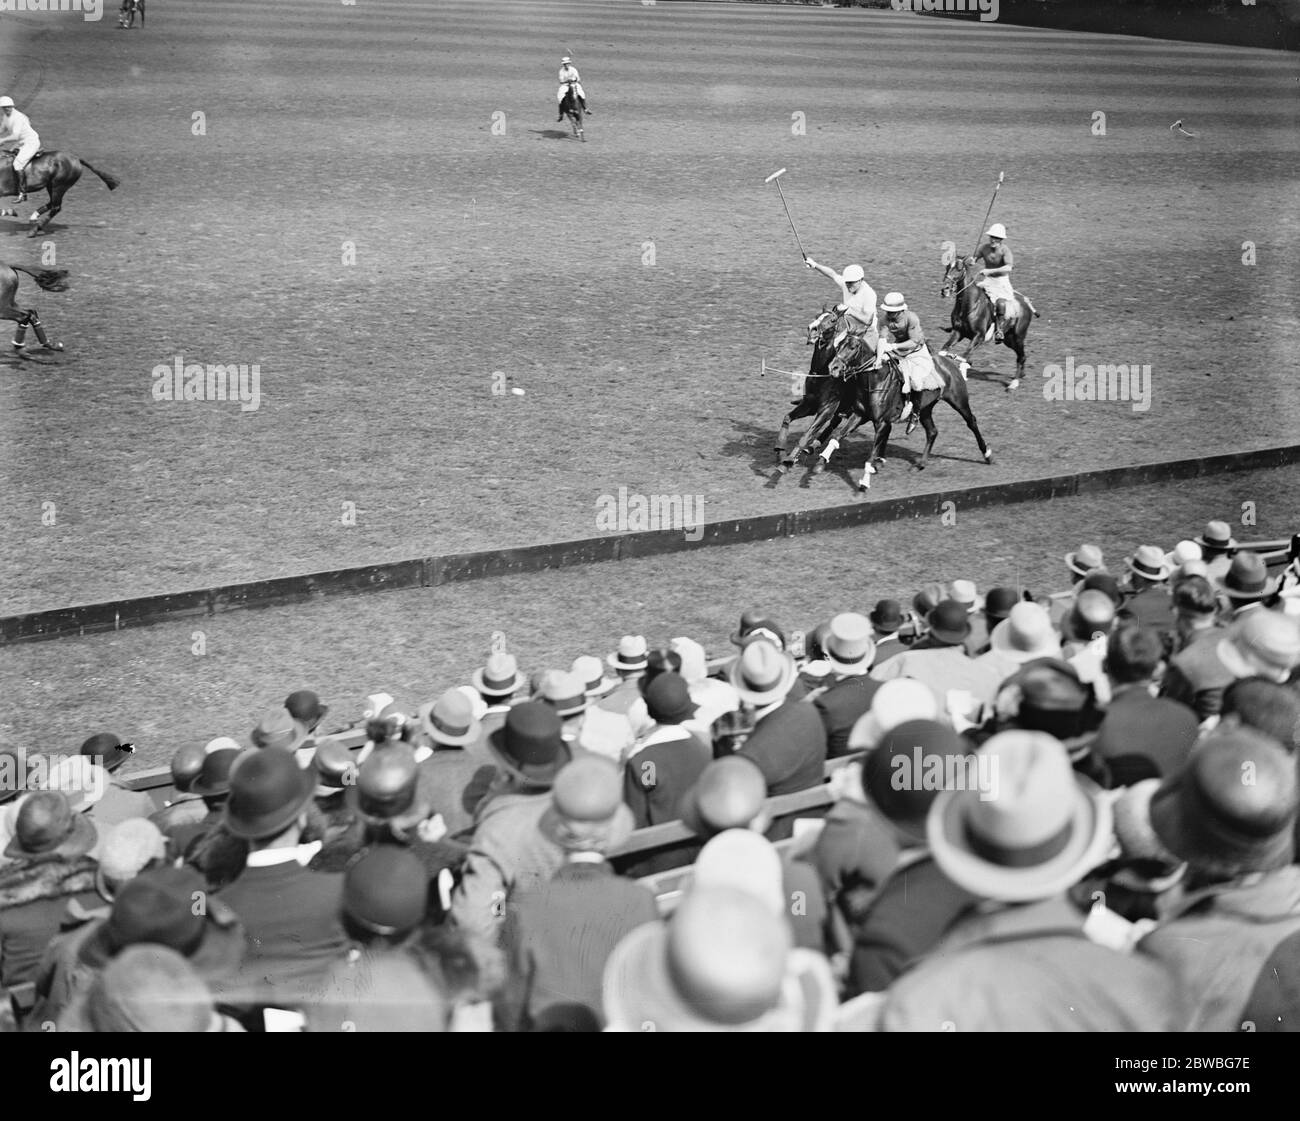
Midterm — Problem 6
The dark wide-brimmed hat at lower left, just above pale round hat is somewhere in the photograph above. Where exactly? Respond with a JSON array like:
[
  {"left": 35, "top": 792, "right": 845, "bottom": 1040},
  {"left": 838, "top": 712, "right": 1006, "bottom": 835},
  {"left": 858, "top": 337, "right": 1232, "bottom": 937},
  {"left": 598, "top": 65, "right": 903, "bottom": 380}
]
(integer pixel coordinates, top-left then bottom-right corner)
[{"left": 78, "top": 866, "right": 244, "bottom": 978}]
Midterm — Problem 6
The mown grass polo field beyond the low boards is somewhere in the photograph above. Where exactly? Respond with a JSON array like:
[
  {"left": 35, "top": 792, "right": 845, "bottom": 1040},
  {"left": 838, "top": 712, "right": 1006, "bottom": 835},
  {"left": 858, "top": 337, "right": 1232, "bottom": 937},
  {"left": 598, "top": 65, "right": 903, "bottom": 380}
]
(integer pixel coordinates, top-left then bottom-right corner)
[{"left": 0, "top": 0, "right": 1300, "bottom": 764}]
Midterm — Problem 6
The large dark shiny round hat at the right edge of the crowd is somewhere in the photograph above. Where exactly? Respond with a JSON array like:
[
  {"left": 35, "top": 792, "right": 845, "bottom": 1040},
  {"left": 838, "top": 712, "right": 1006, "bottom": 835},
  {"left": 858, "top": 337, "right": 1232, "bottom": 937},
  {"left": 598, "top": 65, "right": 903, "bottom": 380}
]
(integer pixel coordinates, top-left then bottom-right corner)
[{"left": 1151, "top": 727, "right": 1296, "bottom": 878}]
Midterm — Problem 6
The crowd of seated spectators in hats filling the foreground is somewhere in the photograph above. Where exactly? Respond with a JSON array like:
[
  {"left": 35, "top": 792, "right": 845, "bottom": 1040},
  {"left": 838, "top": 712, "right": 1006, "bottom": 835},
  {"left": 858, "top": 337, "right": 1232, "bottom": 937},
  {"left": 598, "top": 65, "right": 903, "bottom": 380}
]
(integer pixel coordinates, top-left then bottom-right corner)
[{"left": 0, "top": 521, "right": 1300, "bottom": 1031}]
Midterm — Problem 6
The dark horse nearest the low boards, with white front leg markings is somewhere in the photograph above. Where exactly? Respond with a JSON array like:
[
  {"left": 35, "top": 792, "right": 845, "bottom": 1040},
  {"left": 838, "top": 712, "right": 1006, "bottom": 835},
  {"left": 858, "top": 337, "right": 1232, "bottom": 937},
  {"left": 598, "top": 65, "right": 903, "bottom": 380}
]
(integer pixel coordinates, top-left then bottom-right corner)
[{"left": 813, "top": 338, "right": 993, "bottom": 490}]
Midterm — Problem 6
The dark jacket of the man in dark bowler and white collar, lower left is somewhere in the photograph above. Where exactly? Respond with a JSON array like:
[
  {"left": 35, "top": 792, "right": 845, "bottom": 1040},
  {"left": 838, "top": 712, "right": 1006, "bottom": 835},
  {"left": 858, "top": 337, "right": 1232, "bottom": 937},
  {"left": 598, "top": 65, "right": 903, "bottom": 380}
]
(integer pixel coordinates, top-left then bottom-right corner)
[{"left": 218, "top": 860, "right": 347, "bottom": 1003}]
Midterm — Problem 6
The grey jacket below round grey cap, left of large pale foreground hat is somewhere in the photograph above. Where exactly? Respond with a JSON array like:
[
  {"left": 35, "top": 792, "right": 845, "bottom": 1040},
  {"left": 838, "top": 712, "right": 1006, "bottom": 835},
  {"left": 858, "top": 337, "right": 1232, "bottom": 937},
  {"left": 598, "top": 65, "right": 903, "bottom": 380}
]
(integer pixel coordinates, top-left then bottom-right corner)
[{"left": 502, "top": 861, "right": 659, "bottom": 1030}]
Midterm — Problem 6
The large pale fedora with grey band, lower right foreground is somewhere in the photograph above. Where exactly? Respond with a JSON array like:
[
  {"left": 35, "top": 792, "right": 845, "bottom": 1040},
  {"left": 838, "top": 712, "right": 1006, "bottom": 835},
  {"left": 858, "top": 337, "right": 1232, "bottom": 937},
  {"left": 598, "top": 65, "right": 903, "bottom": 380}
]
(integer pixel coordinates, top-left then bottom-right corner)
[{"left": 926, "top": 730, "right": 1112, "bottom": 903}]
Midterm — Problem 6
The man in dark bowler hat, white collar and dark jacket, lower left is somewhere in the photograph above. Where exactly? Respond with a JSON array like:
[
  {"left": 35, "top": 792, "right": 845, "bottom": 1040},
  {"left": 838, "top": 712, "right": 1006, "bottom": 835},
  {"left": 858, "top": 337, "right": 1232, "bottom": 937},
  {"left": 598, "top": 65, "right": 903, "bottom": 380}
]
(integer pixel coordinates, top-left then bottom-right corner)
[{"left": 220, "top": 750, "right": 346, "bottom": 1004}]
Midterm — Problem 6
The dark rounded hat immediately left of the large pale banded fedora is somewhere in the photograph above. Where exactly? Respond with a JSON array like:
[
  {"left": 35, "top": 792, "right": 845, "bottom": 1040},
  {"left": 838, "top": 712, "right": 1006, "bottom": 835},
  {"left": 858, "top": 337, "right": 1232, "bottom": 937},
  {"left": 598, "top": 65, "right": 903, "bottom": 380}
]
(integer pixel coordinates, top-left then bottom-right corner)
[{"left": 862, "top": 720, "right": 975, "bottom": 845}]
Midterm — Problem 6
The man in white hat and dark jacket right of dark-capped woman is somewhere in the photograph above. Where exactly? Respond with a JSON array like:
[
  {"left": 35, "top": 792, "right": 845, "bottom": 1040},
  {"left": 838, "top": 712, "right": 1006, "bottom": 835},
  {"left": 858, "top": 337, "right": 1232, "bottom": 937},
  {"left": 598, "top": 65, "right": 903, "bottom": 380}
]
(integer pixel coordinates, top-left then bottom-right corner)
[{"left": 731, "top": 639, "right": 826, "bottom": 801}]
